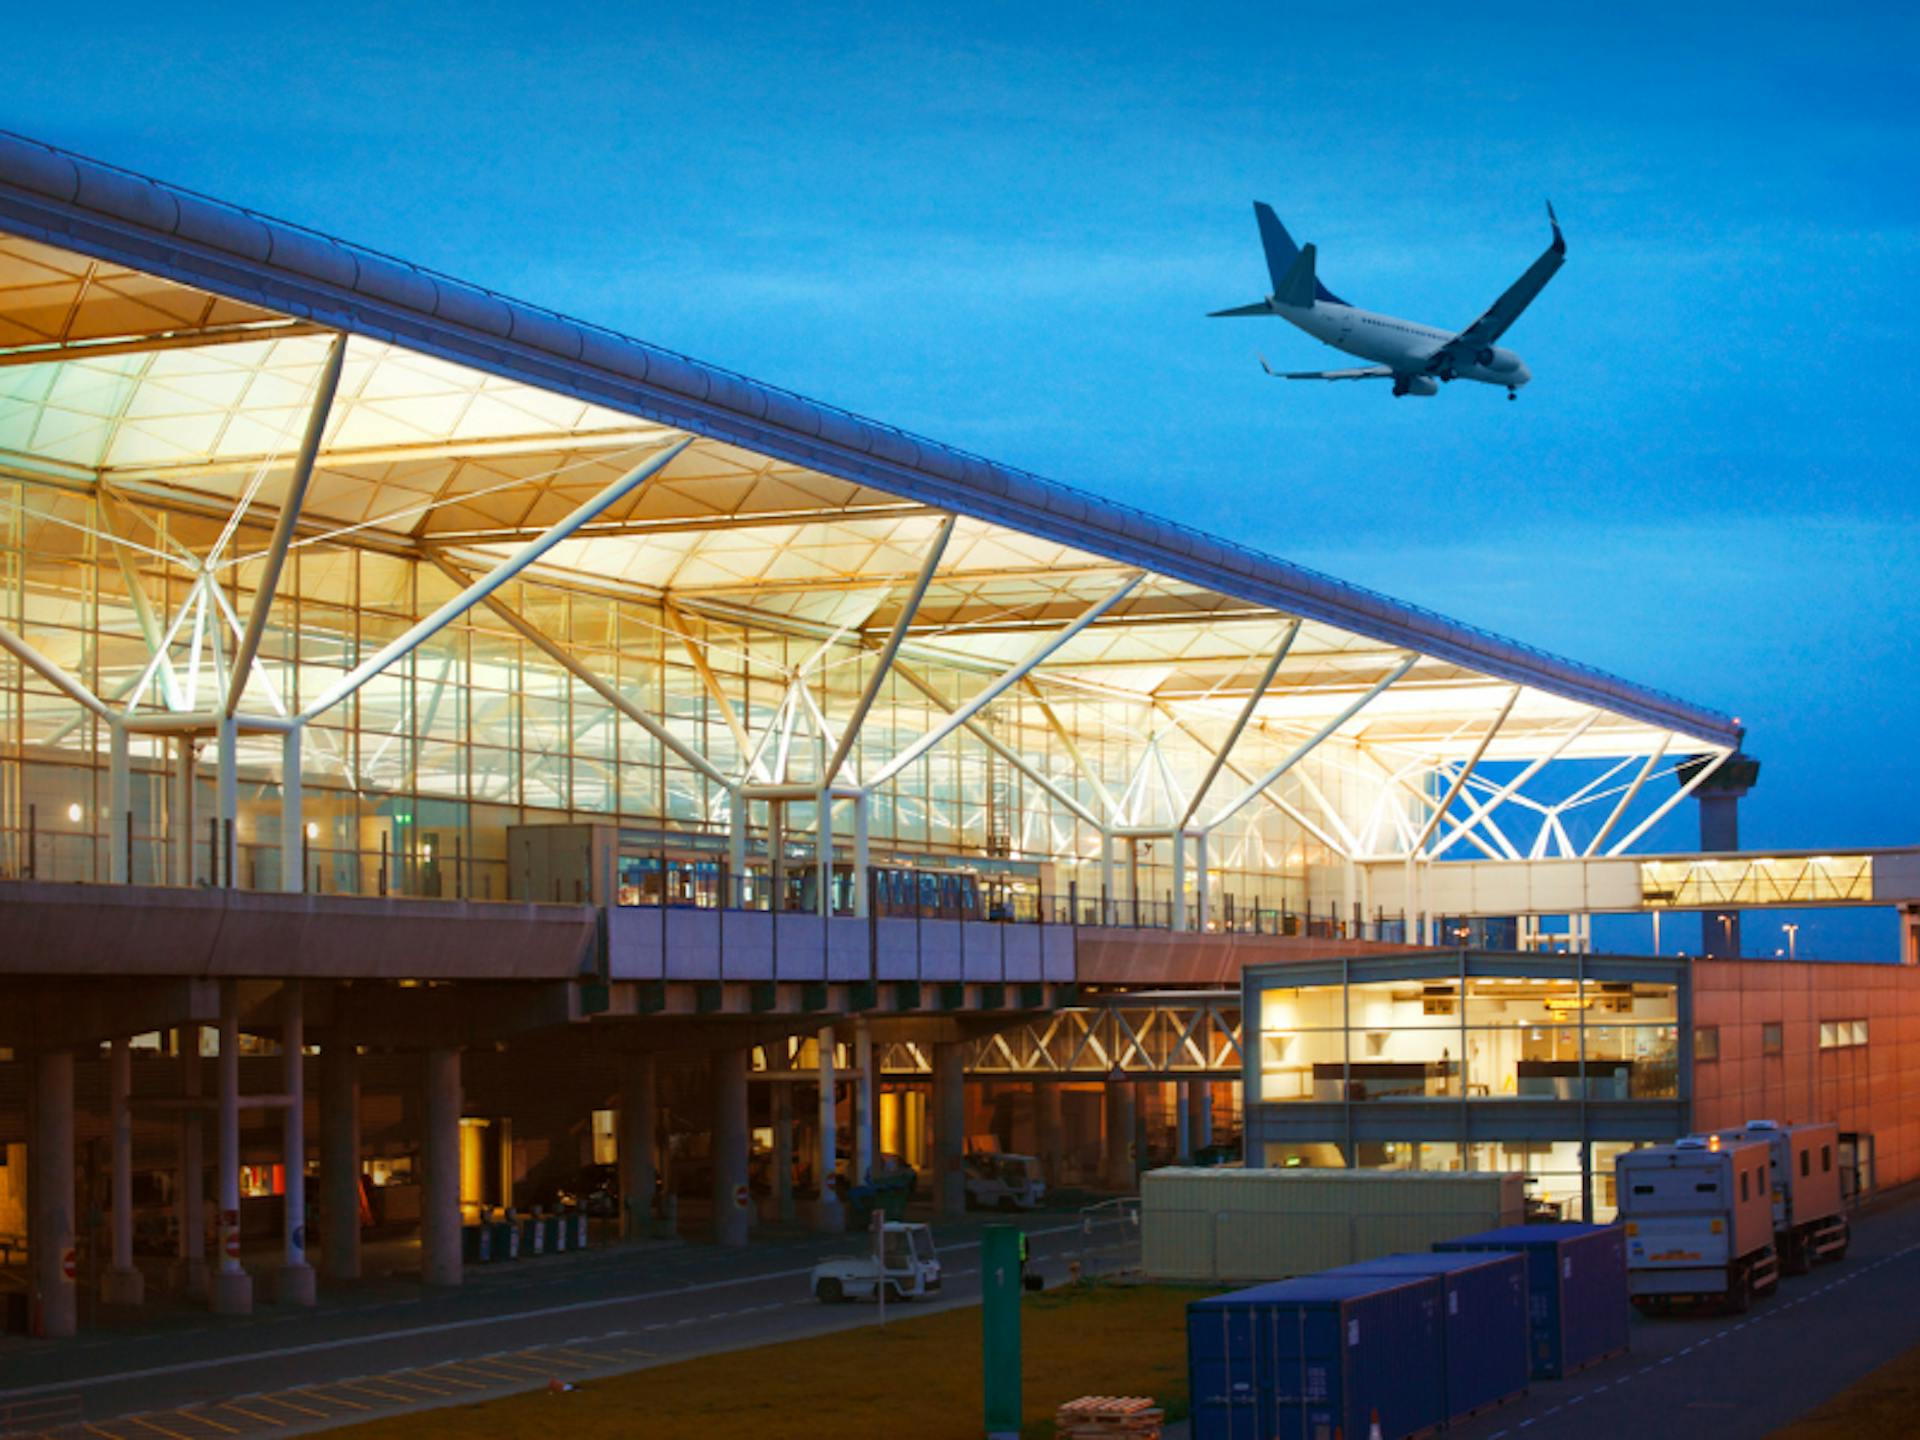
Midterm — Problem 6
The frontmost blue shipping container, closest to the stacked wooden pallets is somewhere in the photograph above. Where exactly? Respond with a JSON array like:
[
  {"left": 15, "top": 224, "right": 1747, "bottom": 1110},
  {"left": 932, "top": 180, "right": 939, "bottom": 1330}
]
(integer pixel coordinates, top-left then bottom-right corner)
[{"left": 1187, "top": 1275, "right": 1446, "bottom": 1440}]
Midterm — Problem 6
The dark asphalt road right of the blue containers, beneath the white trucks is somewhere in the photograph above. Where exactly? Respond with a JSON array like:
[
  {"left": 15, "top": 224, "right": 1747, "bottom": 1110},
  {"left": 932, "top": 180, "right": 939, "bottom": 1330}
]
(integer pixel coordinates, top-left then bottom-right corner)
[{"left": 1450, "top": 1200, "right": 1920, "bottom": 1440}]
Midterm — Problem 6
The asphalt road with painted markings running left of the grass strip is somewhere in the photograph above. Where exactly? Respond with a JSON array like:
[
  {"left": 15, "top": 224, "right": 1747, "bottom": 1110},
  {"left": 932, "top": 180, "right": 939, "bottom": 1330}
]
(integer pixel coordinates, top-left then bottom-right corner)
[{"left": 0, "top": 1213, "right": 1112, "bottom": 1434}]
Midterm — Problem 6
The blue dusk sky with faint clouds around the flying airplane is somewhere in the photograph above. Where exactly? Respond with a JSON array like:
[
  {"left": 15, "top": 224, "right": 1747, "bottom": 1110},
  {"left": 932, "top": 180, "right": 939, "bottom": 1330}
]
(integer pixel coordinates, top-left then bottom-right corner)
[{"left": 0, "top": 0, "right": 1920, "bottom": 958}]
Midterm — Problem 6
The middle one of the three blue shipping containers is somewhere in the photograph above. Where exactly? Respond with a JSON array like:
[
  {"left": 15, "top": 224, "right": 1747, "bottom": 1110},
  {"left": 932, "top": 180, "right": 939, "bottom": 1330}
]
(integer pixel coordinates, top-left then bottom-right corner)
[{"left": 1327, "top": 1250, "right": 1530, "bottom": 1425}]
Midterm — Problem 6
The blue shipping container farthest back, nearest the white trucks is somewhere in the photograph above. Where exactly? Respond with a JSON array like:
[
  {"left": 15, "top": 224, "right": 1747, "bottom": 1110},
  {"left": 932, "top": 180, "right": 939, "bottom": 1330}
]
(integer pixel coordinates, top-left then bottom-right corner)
[{"left": 1434, "top": 1223, "right": 1628, "bottom": 1380}]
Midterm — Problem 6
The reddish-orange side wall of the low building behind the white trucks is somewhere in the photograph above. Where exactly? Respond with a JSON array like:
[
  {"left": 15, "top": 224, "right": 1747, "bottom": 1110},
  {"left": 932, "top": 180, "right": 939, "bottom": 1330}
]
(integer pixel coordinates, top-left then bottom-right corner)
[{"left": 1693, "top": 960, "right": 1920, "bottom": 1187}]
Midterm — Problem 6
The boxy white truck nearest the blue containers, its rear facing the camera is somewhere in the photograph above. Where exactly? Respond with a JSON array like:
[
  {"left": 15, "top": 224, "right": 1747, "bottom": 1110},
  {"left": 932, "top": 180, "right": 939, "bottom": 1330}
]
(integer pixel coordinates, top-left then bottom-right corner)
[{"left": 1613, "top": 1135, "right": 1780, "bottom": 1311}]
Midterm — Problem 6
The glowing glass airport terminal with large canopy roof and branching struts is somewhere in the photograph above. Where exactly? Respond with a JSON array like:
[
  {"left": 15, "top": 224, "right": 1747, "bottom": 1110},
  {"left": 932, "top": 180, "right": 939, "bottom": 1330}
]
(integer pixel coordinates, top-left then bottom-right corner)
[{"left": 0, "top": 136, "right": 1920, "bottom": 1334}]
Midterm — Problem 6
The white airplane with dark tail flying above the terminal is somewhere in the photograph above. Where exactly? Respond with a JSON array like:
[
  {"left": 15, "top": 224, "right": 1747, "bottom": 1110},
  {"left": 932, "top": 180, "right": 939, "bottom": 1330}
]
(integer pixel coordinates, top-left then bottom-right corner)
[{"left": 1212, "top": 200, "right": 1567, "bottom": 399}]
